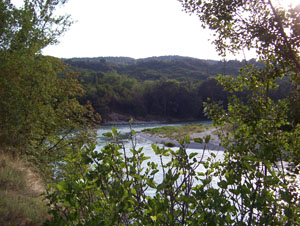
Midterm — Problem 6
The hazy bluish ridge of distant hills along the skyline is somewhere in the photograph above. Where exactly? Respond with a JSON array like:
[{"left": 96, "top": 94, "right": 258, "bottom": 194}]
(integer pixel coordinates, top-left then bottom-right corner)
[{"left": 63, "top": 56, "right": 255, "bottom": 81}]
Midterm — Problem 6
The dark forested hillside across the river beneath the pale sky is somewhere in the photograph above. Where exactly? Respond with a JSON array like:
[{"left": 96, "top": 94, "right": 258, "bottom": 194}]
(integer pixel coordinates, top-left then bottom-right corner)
[{"left": 64, "top": 56, "right": 289, "bottom": 122}]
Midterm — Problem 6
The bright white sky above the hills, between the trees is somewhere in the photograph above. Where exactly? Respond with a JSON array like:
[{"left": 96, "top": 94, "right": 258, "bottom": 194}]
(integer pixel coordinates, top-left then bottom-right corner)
[{"left": 23, "top": 0, "right": 299, "bottom": 59}]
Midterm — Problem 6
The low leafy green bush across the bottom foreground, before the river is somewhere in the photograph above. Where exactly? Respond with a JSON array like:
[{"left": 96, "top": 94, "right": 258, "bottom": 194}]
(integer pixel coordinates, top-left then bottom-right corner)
[{"left": 45, "top": 128, "right": 299, "bottom": 225}]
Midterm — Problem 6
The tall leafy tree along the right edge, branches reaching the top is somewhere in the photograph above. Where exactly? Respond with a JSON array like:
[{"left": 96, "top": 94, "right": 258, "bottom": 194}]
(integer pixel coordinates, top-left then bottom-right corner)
[{"left": 181, "top": 0, "right": 300, "bottom": 225}]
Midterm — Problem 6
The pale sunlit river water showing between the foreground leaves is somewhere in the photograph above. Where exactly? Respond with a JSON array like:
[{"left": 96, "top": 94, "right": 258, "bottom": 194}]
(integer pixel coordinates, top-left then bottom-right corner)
[{"left": 97, "top": 121, "right": 224, "bottom": 195}]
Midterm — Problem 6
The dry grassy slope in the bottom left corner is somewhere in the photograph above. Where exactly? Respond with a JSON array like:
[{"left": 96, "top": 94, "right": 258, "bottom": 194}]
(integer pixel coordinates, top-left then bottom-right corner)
[{"left": 0, "top": 153, "right": 48, "bottom": 226}]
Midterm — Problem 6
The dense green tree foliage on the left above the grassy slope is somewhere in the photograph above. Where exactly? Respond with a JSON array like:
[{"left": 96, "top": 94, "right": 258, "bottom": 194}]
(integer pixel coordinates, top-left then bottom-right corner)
[{"left": 0, "top": 0, "right": 98, "bottom": 180}]
